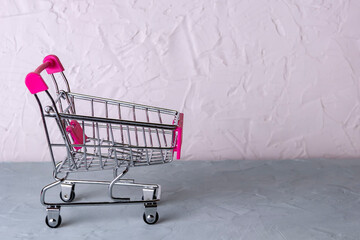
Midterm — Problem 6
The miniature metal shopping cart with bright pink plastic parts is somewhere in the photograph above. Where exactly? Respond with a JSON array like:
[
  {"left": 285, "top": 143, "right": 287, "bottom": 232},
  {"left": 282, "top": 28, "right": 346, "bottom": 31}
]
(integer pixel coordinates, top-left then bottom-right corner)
[{"left": 25, "top": 55, "right": 183, "bottom": 228}]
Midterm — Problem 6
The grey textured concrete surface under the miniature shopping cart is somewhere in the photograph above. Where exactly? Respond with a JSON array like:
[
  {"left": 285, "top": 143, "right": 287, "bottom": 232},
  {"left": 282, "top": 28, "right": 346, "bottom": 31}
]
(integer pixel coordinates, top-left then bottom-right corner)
[{"left": 0, "top": 160, "right": 360, "bottom": 240}]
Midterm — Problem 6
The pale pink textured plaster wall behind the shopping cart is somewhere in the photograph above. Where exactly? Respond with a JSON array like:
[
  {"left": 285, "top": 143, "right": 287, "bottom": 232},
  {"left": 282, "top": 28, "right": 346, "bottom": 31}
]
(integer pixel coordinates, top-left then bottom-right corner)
[{"left": 0, "top": 0, "right": 360, "bottom": 161}]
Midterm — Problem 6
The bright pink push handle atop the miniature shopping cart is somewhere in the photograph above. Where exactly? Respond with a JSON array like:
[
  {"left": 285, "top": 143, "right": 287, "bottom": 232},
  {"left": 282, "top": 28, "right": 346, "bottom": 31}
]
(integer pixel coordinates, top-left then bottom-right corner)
[{"left": 25, "top": 55, "right": 64, "bottom": 94}]
